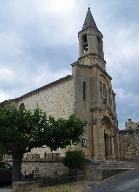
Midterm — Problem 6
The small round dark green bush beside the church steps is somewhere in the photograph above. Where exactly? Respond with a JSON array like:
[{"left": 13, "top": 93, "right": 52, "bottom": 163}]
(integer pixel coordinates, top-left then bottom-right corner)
[{"left": 63, "top": 151, "right": 85, "bottom": 170}]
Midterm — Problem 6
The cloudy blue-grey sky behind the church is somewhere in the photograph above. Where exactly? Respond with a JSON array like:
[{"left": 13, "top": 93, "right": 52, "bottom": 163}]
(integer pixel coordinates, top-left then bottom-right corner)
[{"left": 0, "top": 0, "right": 139, "bottom": 128}]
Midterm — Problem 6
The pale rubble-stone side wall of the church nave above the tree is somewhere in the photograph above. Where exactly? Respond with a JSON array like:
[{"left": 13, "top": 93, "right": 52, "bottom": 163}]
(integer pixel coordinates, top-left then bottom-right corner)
[{"left": 17, "top": 76, "right": 75, "bottom": 158}]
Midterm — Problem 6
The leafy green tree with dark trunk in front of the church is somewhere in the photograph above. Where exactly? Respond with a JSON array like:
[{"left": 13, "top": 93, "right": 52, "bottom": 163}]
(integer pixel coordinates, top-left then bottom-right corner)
[{"left": 0, "top": 106, "right": 86, "bottom": 182}]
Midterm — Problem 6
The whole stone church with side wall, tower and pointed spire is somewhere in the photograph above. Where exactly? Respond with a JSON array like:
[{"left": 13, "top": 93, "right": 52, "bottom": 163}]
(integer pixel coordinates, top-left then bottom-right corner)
[{"left": 1, "top": 8, "right": 119, "bottom": 160}]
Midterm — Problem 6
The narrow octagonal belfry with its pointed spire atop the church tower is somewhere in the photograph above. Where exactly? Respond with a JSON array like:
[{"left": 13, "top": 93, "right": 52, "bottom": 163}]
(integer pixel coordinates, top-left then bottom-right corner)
[{"left": 78, "top": 7, "right": 105, "bottom": 69}]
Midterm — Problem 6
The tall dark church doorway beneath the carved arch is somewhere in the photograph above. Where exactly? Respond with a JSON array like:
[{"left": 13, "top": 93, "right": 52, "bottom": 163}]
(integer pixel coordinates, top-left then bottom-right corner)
[{"left": 102, "top": 117, "right": 113, "bottom": 160}]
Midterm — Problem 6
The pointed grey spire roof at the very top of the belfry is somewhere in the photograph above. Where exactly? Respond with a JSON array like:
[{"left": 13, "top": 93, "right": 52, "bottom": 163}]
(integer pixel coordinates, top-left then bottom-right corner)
[{"left": 82, "top": 7, "right": 98, "bottom": 30}]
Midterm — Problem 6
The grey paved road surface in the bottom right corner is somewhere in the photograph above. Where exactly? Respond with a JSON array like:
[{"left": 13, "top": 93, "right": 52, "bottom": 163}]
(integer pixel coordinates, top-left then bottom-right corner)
[{"left": 91, "top": 168, "right": 139, "bottom": 192}]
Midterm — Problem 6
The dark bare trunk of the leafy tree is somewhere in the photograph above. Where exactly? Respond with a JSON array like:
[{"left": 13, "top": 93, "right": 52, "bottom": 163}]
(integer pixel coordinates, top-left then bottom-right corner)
[{"left": 12, "top": 154, "right": 23, "bottom": 182}]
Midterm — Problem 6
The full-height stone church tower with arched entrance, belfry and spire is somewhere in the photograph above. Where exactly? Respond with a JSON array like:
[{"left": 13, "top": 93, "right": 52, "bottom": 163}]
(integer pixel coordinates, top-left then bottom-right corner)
[{"left": 72, "top": 8, "right": 118, "bottom": 160}]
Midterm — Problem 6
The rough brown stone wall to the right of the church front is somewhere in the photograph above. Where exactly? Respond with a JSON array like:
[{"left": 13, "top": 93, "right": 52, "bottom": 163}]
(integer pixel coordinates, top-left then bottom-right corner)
[{"left": 118, "top": 128, "right": 139, "bottom": 160}]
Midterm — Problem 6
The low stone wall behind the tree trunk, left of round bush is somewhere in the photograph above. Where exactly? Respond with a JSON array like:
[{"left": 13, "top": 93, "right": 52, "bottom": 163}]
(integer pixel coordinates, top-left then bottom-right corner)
[{"left": 3, "top": 153, "right": 68, "bottom": 178}]
